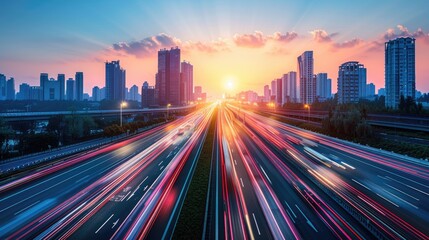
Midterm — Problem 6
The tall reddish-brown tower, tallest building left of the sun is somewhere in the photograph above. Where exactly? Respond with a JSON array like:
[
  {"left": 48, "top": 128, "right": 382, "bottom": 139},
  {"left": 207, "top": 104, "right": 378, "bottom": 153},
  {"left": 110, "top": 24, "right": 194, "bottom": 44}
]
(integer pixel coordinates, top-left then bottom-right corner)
[{"left": 155, "top": 47, "right": 181, "bottom": 106}]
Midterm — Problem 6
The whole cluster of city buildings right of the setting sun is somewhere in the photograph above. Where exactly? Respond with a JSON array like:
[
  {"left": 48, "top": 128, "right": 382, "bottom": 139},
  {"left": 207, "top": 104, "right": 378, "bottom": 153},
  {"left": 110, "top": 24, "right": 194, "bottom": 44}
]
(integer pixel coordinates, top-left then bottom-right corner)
[{"left": 241, "top": 37, "right": 419, "bottom": 109}]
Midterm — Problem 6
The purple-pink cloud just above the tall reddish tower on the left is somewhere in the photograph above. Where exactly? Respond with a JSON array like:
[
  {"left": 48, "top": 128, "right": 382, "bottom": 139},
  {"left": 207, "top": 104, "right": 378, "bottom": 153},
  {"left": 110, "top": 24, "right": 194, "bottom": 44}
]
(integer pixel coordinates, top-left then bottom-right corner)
[{"left": 113, "top": 33, "right": 181, "bottom": 57}]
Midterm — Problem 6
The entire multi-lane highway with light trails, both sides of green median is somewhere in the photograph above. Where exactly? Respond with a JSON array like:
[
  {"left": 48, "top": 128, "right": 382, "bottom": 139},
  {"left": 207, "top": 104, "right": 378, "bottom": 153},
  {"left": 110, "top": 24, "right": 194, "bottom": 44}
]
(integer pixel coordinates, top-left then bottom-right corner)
[{"left": 0, "top": 103, "right": 429, "bottom": 239}]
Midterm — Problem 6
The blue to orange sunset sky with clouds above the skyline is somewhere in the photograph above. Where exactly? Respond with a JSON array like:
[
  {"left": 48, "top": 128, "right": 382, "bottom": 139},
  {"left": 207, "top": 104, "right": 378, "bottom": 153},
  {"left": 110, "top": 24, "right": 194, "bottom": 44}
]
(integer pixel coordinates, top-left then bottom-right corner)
[{"left": 0, "top": 0, "right": 429, "bottom": 98}]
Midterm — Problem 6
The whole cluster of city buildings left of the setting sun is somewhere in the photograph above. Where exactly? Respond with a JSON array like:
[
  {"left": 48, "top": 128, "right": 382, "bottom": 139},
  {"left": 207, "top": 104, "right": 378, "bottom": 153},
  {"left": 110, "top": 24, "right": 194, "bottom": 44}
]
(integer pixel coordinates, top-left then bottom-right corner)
[{"left": 0, "top": 47, "right": 207, "bottom": 108}]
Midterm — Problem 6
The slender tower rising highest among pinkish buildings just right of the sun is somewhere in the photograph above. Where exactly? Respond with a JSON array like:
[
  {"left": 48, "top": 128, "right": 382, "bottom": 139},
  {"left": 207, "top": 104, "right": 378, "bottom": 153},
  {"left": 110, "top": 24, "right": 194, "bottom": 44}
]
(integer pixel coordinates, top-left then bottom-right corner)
[{"left": 298, "top": 51, "right": 316, "bottom": 104}]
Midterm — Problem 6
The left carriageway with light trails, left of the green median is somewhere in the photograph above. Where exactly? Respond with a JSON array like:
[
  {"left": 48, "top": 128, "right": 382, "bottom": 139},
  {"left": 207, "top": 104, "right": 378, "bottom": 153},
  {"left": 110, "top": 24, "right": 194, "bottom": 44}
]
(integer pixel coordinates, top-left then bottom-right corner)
[{"left": 0, "top": 104, "right": 213, "bottom": 239}]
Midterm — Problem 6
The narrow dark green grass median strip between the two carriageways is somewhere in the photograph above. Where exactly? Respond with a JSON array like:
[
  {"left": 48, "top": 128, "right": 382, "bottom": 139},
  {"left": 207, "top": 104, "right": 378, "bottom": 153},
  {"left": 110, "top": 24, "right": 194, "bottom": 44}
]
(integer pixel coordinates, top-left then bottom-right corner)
[{"left": 173, "top": 110, "right": 217, "bottom": 239}]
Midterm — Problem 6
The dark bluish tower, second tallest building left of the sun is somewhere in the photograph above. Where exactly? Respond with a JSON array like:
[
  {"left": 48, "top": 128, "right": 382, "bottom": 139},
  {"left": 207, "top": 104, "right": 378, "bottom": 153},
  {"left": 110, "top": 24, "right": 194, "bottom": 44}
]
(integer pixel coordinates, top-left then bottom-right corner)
[{"left": 106, "top": 60, "right": 126, "bottom": 101}]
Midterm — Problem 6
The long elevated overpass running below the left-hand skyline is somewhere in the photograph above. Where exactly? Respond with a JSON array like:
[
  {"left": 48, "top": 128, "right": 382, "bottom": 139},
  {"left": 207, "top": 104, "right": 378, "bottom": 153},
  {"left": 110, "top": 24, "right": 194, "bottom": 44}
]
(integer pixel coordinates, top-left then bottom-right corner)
[{"left": 0, "top": 105, "right": 196, "bottom": 122}]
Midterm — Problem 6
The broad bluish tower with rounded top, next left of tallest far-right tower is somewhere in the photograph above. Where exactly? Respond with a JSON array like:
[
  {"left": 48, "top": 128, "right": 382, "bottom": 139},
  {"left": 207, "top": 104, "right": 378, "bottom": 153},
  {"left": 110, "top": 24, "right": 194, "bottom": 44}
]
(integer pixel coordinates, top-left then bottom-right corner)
[{"left": 337, "top": 62, "right": 366, "bottom": 104}]
